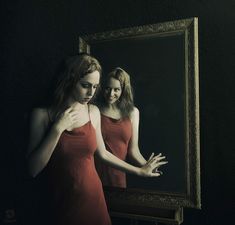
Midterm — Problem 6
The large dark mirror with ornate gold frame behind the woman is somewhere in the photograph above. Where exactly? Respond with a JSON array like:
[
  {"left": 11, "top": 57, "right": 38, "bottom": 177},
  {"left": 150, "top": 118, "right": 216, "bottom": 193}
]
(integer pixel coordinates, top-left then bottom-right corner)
[{"left": 79, "top": 18, "right": 201, "bottom": 220}]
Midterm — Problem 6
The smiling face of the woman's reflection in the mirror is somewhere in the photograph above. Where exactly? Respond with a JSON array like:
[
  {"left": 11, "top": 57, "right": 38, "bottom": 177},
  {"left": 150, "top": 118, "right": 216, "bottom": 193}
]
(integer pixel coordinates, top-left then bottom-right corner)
[{"left": 104, "top": 77, "right": 122, "bottom": 104}]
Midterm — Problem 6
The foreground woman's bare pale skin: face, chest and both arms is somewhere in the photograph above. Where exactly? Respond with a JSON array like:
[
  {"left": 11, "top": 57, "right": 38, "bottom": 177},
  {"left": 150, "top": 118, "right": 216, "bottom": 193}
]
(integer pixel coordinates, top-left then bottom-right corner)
[{"left": 28, "top": 71, "right": 167, "bottom": 177}]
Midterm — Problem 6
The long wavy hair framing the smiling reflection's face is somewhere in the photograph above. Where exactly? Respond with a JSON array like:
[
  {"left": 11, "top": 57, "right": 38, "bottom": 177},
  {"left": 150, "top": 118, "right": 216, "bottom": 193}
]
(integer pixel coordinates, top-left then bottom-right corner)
[{"left": 98, "top": 67, "right": 134, "bottom": 118}]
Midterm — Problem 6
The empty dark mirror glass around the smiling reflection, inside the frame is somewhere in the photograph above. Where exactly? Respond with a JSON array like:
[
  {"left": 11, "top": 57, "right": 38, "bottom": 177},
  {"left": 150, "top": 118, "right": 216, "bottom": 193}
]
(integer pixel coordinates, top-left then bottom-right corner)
[{"left": 86, "top": 27, "right": 187, "bottom": 192}]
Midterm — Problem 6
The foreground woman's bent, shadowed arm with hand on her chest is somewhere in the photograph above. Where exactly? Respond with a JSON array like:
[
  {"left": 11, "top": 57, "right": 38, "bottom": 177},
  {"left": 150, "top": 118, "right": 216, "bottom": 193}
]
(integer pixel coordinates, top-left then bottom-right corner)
[{"left": 27, "top": 107, "right": 78, "bottom": 177}]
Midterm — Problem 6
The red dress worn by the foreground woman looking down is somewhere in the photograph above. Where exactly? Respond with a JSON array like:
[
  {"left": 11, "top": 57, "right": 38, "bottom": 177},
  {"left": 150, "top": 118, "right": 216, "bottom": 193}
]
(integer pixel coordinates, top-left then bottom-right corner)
[{"left": 47, "top": 121, "right": 111, "bottom": 225}]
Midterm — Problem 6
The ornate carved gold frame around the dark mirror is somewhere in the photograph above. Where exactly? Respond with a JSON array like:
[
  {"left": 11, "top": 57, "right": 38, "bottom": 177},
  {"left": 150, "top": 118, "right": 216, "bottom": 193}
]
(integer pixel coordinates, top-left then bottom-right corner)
[{"left": 79, "top": 18, "right": 201, "bottom": 224}]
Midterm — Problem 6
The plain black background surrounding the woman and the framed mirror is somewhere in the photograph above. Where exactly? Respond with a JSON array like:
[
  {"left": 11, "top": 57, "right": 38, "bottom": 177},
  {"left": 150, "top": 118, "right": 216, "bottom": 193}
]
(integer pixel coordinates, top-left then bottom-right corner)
[{"left": 0, "top": 0, "right": 235, "bottom": 225}]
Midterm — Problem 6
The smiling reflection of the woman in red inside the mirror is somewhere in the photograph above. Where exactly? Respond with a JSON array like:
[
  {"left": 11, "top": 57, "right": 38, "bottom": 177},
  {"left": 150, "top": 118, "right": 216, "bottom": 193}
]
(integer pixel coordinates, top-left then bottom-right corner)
[{"left": 96, "top": 67, "right": 165, "bottom": 188}]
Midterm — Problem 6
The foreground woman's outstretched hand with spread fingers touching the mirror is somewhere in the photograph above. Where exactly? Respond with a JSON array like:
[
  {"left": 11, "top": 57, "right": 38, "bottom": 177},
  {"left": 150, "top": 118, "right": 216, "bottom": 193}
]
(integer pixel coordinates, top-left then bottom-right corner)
[{"left": 141, "top": 153, "right": 168, "bottom": 177}]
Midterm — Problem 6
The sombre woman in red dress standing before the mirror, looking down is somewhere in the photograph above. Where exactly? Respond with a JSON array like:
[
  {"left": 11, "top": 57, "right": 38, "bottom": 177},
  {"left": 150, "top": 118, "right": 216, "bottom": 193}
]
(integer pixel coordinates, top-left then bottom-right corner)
[{"left": 28, "top": 54, "right": 166, "bottom": 225}]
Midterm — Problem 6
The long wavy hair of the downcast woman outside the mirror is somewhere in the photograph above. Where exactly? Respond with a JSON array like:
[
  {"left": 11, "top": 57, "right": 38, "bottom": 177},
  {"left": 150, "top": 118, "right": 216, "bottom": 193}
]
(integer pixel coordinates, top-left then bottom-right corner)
[{"left": 50, "top": 53, "right": 102, "bottom": 117}]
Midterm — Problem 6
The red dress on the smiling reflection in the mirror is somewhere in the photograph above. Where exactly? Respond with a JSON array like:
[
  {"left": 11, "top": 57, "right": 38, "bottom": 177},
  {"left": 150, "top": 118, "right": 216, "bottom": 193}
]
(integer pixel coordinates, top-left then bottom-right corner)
[{"left": 96, "top": 114, "right": 132, "bottom": 188}]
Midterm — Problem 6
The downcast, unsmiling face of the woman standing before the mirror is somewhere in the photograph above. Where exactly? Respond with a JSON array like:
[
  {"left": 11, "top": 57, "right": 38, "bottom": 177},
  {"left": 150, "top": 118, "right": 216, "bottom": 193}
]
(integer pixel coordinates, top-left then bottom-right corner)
[{"left": 74, "top": 70, "right": 100, "bottom": 104}]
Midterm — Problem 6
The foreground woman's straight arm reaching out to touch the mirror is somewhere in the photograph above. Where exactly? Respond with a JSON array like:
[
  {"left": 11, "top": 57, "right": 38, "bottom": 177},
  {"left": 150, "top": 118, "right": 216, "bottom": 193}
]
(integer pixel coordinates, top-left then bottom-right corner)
[{"left": 92, "top": 106, "right": 167, "bottom": 177}]
